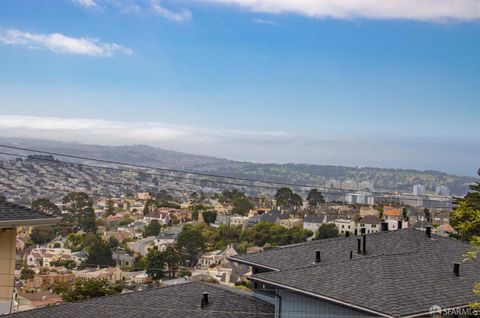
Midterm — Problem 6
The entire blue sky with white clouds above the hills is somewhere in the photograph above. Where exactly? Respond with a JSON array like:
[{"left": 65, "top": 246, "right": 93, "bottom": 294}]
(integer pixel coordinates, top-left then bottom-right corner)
[{"left": 0, "top": 0, "right": 480, "bottom": 175}]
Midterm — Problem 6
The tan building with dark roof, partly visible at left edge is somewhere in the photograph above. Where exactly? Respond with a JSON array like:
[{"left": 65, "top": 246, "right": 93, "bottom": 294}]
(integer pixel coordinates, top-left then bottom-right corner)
[{"left": 0, "top": 201, "right": 60, "bottom": 314}]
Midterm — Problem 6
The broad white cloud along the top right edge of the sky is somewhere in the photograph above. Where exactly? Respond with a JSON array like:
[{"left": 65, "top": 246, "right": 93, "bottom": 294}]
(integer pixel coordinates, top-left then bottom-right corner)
[{"left": 202, "top": 0, "right": 480, "bottom": 21}]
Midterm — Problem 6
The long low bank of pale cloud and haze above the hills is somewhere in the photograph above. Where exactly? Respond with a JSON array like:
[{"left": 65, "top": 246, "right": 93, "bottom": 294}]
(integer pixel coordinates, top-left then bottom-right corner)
[{"left": 0, "top": 115, "right": 480, "bottom": 175}]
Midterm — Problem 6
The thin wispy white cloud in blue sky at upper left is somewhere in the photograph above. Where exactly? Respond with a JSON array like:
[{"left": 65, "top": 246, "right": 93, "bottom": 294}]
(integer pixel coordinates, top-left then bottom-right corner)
[{"left": 0, "top": 29, "right": 133, "bottom": 57}]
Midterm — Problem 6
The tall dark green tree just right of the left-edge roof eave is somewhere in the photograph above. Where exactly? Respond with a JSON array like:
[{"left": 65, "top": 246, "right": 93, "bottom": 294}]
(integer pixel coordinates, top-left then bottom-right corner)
[{"left": 63, "top": 192, "right": 97, "bottom": 233}]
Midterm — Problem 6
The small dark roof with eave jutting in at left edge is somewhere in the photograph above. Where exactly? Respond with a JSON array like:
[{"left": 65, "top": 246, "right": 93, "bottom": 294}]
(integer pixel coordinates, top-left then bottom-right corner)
[{"left": 0, "top": 201, "right": 61, "bottom": 228}]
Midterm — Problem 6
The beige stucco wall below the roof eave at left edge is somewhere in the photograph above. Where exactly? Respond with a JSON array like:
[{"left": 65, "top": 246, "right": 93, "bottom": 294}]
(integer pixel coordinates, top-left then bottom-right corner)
[{"left": 0, "top": 229, "right": 17, "bottom": 314}]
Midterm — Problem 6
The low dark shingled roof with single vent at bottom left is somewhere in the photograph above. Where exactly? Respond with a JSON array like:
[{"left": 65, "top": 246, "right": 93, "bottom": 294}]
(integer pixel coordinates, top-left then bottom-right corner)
[{"left": 10, "top": 282, "right": 275, "bottom": 318}]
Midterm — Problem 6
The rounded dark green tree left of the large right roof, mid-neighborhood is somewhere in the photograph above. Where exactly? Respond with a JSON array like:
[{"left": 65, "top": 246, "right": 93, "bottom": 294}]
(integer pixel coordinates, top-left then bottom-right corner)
[{"left": 177, "top": 224, "right": 206, "bottom": 266}]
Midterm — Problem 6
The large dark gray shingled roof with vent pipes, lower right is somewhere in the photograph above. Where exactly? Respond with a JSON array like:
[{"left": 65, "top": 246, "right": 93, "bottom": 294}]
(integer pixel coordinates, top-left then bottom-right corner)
[{"left": 231, "top": 229, "right": 480, "bottom": 317}]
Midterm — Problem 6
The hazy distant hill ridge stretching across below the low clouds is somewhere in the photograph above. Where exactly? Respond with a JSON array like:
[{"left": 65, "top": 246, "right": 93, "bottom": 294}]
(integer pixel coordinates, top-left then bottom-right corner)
[{"left": 0, "top": 138, "right": 477, "bottom": 196}]
